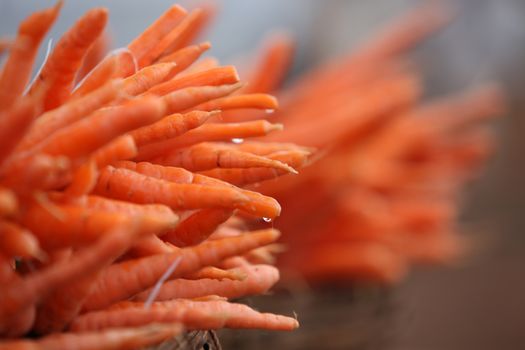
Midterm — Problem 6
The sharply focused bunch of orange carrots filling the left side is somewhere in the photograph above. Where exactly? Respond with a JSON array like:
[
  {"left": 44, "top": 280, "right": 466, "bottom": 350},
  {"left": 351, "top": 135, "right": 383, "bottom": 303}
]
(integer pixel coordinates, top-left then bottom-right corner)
[{"left": 0, "top": 2, "right": 310, "bottom": 349}]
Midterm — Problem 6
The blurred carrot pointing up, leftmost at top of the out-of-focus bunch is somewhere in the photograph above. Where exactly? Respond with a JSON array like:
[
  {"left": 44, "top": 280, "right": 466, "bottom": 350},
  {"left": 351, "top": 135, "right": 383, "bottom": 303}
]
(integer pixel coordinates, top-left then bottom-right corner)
[{"left": 243, "top": 34, "right": 294, "bottom": 93}]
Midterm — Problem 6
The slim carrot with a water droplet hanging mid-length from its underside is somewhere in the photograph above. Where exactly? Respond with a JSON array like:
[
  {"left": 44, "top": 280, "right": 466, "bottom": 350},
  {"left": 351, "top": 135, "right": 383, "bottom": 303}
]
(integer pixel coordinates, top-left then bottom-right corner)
[{"left": 145, "top": 120, "right": 283, "bottom": 150}]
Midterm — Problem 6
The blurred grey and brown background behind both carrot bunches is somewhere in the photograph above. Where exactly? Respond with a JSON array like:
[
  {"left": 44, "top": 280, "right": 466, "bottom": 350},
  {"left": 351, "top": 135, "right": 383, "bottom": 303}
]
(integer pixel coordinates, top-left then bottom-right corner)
[{"left": 0, "top": 0, "right": 525, "bottom": 350}]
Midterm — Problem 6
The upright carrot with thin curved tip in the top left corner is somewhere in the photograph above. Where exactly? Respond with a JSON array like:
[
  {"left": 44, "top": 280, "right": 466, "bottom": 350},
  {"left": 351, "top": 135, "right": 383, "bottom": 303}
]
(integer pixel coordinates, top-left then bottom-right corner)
[{"left": 0, "top": 1, "right": 62, "bottom": 109}]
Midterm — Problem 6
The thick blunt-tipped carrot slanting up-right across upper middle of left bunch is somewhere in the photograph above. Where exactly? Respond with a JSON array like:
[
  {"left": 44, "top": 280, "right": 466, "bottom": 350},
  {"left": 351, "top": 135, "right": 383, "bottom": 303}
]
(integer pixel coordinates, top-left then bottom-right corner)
[{"left": 30, "top": 97, "right": 164, "bottom": 159}]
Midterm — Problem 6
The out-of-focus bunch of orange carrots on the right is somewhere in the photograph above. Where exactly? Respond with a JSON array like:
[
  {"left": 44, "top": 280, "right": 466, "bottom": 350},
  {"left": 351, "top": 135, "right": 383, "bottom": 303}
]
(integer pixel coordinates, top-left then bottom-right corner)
[{"left": 226, "top": 2, "right": 503, "bottom": 283}]
